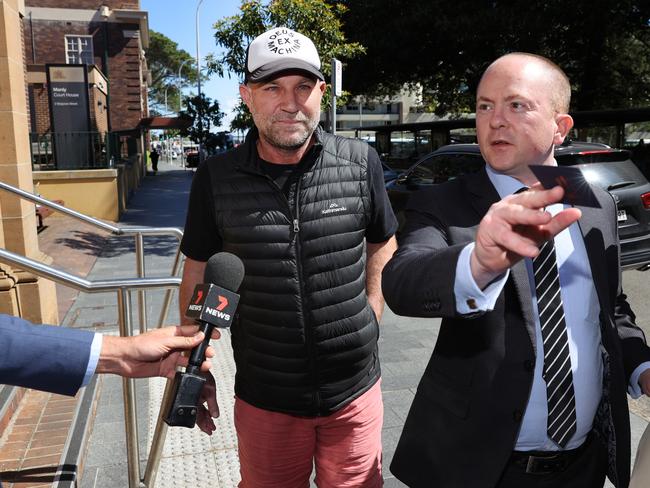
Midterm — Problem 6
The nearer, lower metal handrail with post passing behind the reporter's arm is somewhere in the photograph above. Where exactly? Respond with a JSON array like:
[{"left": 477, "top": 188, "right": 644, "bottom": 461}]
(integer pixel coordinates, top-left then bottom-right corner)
[{"left": 0, "top": 248, "right": 181, "bottom": 488}]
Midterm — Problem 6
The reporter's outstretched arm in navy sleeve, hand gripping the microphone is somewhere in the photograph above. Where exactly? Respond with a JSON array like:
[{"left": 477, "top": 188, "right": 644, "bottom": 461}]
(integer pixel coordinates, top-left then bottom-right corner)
[{"left": 0, "top": 314, "right": 216, "bottom": 395}]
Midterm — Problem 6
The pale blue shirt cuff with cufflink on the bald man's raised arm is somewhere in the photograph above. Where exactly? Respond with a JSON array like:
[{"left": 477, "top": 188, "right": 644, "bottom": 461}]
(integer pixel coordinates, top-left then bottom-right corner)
[{"left": 454, "top": 242, "right": 510, "bottom": 315}]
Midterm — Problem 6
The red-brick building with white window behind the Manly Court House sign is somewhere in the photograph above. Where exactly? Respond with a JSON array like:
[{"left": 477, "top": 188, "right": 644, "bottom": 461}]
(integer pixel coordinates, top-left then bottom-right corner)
[{"left": 23, "top": 0, "right": 149, "bottom": 134}]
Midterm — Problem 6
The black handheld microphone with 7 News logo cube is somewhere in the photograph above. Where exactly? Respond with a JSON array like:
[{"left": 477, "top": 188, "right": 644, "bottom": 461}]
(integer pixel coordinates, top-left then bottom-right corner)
[{"left": 164, "top": 252, "right": 244, "bottom": 428}]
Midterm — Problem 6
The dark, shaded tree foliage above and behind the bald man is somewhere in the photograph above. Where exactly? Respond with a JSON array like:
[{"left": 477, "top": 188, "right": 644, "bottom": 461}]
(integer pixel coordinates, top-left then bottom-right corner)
[{"left": 331, "top": 0, "right": 650, "bottom": 114}]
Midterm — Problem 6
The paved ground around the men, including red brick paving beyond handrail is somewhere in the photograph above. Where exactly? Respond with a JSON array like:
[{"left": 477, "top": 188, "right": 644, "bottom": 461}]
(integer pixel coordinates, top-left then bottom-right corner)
[{"left": 0, "top": 160, "right": 650, "bottom": 488}]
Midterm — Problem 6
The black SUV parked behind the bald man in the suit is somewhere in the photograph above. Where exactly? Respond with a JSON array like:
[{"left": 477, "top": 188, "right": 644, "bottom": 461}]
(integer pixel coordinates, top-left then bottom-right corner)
[{"left": 386, "top": 141, "right": 650, "bottom": 269}]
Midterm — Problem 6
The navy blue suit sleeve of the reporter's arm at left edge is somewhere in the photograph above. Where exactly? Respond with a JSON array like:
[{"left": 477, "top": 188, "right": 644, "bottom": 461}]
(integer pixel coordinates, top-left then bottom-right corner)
[{"left": 0, "top": 315, "right": 94, "bottom": 395}]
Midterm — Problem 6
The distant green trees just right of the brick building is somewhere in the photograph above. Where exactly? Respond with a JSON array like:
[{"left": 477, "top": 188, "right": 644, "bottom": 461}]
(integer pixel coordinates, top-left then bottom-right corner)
[{"left": 146, "top": 31, "right": 197, "bottom": 113}]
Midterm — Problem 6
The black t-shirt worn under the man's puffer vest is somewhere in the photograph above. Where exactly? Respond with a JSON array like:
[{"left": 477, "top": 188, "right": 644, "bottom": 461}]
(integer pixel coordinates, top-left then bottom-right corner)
[{"left": 181, "top": 142, "right": 397, "bottom": 261}]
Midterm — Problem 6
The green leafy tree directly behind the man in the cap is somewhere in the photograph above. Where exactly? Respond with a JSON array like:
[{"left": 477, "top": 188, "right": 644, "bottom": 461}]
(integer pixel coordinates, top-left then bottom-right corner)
[{"left": 208, "top": 0, "right": 364, "bottom": 130}]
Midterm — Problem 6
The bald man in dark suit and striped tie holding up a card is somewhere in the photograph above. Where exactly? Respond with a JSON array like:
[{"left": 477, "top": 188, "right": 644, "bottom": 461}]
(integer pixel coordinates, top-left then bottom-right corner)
[{"left": 383, "top": 53, "right": 650, "bottom": 488}]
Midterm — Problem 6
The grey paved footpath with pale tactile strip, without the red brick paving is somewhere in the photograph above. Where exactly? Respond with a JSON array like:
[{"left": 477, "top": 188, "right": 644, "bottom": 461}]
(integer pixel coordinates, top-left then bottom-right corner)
[{"left": 73, "top": 160, "right": 648, "bottom": 488}]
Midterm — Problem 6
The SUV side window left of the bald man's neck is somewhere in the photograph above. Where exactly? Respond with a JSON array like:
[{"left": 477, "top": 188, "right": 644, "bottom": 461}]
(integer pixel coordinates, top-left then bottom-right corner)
[{"left": 410, "top": 154, "right": 485, "bottom": 185}]
